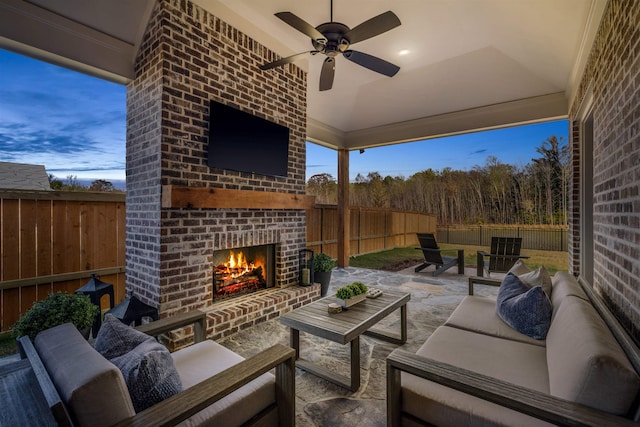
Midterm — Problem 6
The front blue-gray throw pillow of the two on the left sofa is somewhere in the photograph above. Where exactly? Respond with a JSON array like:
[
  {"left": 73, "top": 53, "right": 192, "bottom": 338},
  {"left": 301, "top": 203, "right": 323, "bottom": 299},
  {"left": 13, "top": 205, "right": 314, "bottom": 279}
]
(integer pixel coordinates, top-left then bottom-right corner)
[{"left": 111, "top": 338, "right": 182, "bottom": 412}]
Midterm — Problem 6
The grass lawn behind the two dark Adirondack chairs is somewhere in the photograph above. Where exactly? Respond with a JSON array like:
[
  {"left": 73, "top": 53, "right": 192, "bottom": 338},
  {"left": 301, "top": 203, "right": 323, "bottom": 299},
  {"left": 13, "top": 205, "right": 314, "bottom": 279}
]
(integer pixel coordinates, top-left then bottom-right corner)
[{"left": 349, "top": 243, "right": 569, "bottom": 274}]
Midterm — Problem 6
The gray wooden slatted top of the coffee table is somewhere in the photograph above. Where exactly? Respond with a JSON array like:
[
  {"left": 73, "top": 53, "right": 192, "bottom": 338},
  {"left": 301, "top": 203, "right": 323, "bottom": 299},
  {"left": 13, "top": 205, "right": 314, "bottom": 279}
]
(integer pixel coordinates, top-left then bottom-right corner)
[{"left": 280, "top": 290, "right": 411, "bottom": 344}]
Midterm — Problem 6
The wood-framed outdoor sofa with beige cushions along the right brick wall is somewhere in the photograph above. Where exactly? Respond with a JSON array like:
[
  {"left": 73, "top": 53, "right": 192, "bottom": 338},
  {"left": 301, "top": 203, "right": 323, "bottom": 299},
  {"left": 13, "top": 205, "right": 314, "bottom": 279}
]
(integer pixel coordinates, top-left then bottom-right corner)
[{"left": 387, "top": 272, "right": 640, "bottom": 426}]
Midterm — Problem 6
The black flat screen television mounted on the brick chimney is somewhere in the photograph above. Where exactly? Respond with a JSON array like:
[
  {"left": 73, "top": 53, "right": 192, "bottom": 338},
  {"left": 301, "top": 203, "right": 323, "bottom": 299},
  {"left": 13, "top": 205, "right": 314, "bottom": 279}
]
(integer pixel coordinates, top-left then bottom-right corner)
[{"left": 208, "top": 101, "right": 289, "bottom": 177}]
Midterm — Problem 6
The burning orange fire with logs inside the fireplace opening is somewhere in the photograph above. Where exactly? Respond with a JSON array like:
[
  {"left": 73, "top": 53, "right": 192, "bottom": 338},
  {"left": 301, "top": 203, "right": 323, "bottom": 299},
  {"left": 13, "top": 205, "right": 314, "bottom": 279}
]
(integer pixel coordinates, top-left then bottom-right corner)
[{"left": 213, "top": 245, "right": 275, "bottom": 301}]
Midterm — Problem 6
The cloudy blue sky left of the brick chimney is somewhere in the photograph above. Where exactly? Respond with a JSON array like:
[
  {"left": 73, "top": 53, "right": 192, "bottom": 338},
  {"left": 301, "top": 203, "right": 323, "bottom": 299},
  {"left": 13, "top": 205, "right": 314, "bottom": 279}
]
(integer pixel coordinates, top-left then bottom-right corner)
[{"left": 0, "top": 50, "right": 126, "bottom": 179}]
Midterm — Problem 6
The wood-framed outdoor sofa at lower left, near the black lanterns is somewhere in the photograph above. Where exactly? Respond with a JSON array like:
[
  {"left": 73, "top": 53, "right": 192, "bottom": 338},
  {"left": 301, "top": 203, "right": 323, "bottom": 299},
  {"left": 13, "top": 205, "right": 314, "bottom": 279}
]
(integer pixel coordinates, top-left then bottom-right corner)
[{"left": 19, "top": 310, "right": 295, "bottom": 427}]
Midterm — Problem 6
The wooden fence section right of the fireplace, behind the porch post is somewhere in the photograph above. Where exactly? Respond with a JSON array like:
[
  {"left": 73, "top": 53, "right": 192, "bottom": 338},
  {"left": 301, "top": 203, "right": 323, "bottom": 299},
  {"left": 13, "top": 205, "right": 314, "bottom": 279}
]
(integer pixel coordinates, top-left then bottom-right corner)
[{"left": 307, "top": 205, "right": 436, "bottom": 258}]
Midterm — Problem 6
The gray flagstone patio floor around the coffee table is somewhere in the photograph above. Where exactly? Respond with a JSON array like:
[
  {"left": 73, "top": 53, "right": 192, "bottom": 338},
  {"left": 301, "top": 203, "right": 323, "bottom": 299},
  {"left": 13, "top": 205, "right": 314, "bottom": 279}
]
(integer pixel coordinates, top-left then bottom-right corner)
[{"left": 220, "top": 267, "right": 497, "bottom": 427}]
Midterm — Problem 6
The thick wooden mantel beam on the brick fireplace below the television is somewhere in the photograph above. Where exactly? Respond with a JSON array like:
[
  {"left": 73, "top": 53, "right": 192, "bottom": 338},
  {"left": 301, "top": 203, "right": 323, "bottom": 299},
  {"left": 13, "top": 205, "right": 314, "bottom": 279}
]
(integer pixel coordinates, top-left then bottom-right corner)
[{"left": 162, "top": 185, "right": 315, "bottom": 209}]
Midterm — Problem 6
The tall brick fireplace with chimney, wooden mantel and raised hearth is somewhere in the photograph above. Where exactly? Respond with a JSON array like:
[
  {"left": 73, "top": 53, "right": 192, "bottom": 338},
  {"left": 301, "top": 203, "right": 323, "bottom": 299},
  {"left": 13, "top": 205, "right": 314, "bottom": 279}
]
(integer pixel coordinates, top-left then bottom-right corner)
[{"left": 126, "top": 0, "right": 319, "bottom": 338}]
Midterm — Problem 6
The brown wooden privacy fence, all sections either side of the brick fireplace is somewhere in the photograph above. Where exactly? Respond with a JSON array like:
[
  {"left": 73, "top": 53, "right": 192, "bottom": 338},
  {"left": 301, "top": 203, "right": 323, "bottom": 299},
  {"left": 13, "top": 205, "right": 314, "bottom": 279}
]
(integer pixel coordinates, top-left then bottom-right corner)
[{"left": 0, "top": 190, "right": 436, "bottom": 332}]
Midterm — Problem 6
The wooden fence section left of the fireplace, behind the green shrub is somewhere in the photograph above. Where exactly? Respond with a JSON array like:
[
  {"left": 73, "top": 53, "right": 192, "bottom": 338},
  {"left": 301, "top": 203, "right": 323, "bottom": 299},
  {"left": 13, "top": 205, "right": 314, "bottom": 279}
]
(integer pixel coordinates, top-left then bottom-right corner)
[{"left": 0, "top": 190, "right": 125, "bottom": 331}]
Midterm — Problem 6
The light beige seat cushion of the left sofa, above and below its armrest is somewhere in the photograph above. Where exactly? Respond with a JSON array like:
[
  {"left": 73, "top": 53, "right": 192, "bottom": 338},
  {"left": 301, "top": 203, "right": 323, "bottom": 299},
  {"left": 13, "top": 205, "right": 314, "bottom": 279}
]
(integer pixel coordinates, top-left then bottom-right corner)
[{"left": 172, "top": 340, "right": 278, "bottom": 426}]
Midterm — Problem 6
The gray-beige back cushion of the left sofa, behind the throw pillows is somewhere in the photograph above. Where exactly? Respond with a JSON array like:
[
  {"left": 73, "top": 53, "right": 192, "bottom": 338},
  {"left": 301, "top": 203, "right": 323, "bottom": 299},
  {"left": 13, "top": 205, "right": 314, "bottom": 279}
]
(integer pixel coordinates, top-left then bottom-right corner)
[{"left": 34, "top": 323, "right": 135, "bottom": 427}]
